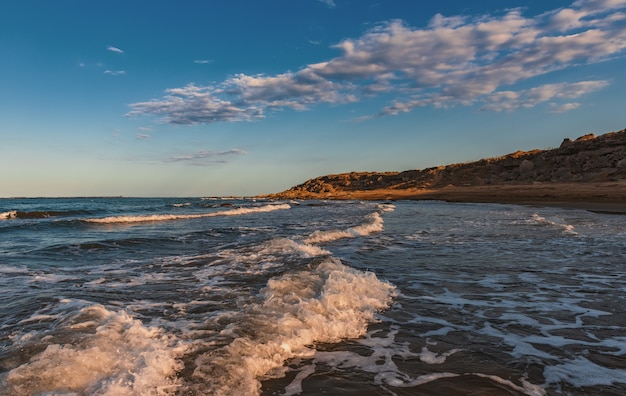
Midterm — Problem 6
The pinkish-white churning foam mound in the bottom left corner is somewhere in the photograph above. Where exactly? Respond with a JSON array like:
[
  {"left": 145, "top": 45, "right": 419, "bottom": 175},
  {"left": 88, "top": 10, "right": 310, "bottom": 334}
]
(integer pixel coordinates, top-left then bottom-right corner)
[{"left": 0, "top": 305, "right": 182, "bottom": 396}]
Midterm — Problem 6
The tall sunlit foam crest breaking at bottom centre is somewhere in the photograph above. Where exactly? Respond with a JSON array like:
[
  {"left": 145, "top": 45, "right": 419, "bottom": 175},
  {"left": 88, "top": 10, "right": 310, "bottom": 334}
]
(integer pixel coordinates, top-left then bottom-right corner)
[{"left": 194, "top": 258, "right": 395, "bottom": 395}]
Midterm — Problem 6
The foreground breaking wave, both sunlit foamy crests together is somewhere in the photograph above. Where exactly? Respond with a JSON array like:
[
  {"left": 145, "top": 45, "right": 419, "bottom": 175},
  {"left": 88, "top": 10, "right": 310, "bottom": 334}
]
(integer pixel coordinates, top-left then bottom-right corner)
[{"left": 0, "top": 257, "right": 397, "bottom": 396}]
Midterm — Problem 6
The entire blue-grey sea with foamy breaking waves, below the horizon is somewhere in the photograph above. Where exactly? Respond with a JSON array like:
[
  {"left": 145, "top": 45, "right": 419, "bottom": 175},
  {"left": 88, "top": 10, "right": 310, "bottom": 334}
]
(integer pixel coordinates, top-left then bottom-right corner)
[{"left": 0, "top": 198, "right": 626, "bottom": 396}]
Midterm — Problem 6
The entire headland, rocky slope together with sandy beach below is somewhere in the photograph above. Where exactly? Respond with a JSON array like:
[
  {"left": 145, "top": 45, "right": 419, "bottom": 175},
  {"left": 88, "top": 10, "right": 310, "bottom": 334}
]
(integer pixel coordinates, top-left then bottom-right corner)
[{"left": 264, "top": 129, "right": 626, "bottom": 213}]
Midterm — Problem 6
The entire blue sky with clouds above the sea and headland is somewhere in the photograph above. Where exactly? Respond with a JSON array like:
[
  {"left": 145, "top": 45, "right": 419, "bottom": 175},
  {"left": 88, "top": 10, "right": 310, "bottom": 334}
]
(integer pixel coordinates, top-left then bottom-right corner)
[{"left": 0, "top": 0, "right": 626, "bottom": 197}]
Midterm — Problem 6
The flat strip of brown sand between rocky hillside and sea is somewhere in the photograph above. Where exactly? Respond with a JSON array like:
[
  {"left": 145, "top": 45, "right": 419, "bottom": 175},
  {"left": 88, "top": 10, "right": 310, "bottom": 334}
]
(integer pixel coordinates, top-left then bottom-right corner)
[{"left": 274, "top": 180, "right": 626, "bottom": 214}]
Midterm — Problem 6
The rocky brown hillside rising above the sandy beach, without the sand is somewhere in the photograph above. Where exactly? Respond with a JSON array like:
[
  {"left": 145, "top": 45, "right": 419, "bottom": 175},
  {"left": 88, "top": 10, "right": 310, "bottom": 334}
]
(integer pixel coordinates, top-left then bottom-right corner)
[{"left": 271, "top": 129, "right": 626, "bottom": 199}]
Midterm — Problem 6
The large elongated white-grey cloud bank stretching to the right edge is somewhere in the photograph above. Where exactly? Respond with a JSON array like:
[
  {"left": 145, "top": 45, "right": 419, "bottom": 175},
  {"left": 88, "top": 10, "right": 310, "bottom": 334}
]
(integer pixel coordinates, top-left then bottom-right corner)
[{"left": 128, "top": 0, "right": 626, "bottom": 124}]
